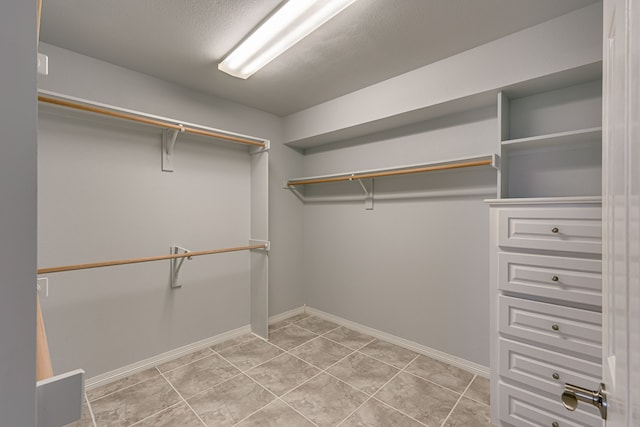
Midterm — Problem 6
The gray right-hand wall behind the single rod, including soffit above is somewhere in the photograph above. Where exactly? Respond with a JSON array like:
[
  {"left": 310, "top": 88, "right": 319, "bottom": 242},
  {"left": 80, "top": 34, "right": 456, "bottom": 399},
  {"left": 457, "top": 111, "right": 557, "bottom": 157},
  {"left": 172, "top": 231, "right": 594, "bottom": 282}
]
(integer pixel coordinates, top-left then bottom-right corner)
[{"left": 284, "top": 3, "right": 602, "bottom": 366}]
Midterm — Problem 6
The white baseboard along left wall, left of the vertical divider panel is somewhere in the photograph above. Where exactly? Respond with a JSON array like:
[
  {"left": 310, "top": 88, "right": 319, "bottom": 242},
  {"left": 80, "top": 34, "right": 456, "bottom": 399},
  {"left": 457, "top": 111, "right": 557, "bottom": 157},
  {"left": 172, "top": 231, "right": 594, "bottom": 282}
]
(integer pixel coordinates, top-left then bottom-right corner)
[{"left": 85, "top": 325, "right": 251, "bottom": 390}]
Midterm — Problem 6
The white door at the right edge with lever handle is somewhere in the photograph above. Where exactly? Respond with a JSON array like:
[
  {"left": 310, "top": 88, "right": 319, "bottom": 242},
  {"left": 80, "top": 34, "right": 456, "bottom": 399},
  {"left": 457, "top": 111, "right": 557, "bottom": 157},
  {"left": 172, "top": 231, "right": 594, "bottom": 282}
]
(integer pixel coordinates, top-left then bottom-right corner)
[{"left": 602, "top": 0, "right": 640, "bottom": 427}]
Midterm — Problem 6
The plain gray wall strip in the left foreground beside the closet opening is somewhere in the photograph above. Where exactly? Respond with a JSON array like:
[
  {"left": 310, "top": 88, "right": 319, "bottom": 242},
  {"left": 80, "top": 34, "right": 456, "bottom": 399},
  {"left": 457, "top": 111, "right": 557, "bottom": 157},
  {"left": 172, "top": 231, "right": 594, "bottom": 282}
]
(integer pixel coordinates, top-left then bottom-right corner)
[{"left": 0, "top": 1, "right": 37, "bottom": 427}]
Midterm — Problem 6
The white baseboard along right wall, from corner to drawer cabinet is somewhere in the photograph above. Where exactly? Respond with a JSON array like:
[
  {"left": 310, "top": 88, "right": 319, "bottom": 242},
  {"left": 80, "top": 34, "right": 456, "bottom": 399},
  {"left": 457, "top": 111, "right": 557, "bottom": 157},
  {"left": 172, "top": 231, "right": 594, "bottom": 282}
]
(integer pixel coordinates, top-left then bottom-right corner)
[{"left": 305, "top": 307, "right": 490, "bottom": 379}]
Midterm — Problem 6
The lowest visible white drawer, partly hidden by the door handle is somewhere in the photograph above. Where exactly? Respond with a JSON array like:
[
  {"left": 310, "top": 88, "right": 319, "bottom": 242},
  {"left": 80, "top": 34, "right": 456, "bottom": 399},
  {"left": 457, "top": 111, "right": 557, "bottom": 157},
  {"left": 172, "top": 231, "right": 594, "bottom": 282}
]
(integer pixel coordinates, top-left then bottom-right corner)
[{"left": 498, "top": 383, "right": 602, "bottom": 427}]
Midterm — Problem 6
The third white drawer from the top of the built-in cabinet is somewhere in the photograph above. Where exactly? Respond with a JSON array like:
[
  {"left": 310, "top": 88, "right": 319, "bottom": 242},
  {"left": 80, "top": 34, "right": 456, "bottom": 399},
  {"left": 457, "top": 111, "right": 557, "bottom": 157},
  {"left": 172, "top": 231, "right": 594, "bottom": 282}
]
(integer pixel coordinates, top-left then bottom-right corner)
[{"left": 498, "top": 295, "right": 602, "bottom": 361}]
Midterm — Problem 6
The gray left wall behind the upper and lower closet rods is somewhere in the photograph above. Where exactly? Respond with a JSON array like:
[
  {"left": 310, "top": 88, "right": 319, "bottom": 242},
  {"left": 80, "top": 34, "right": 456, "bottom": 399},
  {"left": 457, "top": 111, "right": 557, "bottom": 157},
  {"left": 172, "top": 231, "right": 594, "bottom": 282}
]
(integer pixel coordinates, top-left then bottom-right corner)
[{"left": 38, "top": 45, "right": 304, "bottom": 377}]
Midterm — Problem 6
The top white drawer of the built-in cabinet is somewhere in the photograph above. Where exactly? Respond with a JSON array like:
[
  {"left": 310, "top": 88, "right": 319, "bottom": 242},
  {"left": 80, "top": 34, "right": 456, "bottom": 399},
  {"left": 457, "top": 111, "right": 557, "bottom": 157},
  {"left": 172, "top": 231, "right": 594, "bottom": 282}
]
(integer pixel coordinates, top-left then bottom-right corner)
[{"left": 498, "top": 207, "right": 602, "bottom": 254}]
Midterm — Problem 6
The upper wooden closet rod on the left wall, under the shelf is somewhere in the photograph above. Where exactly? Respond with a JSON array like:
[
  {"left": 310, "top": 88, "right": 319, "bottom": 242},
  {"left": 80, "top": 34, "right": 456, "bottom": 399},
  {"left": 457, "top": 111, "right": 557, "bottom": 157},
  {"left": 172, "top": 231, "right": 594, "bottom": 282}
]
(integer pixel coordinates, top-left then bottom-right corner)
[{"left": 38, "top": 95, "right": 266, "bottom": 147}]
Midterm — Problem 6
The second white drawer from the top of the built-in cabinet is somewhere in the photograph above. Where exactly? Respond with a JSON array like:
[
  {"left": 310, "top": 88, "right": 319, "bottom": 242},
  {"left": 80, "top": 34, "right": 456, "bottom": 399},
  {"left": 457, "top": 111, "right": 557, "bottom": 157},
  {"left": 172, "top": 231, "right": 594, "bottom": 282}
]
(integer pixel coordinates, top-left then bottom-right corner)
[{"left": 498, "top": 252, "right": 602, "bottom": 307}]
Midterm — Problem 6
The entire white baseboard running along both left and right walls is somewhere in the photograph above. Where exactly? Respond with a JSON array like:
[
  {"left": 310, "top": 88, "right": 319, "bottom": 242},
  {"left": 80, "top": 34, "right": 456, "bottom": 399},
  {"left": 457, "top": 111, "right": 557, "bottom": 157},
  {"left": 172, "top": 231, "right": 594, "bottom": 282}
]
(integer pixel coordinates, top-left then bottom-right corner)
[{"left": 85, "top": 305, "right": 490, "bottom": 390}]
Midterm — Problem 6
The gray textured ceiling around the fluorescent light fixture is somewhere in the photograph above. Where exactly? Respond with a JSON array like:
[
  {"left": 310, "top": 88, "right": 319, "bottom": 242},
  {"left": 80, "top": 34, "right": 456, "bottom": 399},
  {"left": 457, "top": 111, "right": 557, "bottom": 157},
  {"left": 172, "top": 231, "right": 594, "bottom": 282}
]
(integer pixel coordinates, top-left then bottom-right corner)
[{"left": 40, "top": 0, "right": 597, "bottom": 116}]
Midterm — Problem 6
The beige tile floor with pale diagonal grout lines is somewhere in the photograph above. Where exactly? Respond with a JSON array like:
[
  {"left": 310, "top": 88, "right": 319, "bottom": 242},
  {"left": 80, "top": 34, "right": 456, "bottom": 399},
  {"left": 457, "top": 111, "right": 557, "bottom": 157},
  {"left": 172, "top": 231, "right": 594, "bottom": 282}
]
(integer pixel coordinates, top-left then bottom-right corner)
[{"left": 70, "top": 314, "right": 491, "bottom": 427}]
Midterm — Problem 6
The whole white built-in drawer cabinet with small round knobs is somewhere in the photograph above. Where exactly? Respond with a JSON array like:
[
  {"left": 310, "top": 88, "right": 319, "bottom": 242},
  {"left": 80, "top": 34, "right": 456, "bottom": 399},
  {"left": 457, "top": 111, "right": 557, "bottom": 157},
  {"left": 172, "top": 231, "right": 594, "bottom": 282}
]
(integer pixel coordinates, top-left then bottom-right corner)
[{"left": 488, "top": 197, "right": 602, "bottom": 427}]
